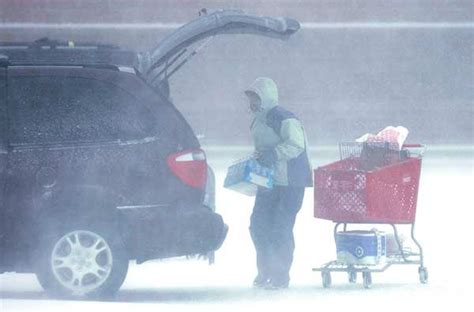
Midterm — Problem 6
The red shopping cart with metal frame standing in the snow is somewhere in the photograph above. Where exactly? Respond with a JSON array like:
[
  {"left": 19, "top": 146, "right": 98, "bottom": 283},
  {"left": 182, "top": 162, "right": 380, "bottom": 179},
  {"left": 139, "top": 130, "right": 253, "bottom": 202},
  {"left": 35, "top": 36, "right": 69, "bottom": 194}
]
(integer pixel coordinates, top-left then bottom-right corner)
[{"left": 313, "top": 142, "right": 428, "bottom": 288}]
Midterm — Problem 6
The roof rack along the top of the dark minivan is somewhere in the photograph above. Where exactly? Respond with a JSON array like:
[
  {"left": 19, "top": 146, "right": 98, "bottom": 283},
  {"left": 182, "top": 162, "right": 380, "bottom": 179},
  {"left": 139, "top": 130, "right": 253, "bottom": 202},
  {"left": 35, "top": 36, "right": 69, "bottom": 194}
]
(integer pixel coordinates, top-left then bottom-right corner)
[{"left": 0, "top": 37, "right": 136, "bottom": 67}]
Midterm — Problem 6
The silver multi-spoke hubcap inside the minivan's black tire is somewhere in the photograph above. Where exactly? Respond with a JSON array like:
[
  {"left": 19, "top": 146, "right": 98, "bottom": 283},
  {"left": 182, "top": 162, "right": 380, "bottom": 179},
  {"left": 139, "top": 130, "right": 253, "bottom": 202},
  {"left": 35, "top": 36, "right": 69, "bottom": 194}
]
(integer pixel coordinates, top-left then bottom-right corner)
[{"left": 51, "top": 231, "right": 113, "bottom": 296}]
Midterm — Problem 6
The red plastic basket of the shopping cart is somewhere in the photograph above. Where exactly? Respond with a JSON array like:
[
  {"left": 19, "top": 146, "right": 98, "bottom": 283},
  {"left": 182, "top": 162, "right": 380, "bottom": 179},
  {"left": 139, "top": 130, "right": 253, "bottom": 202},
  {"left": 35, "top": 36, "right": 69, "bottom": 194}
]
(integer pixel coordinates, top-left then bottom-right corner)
[{"left": 314, "top": 157, "right": 421, "bottom": 223}]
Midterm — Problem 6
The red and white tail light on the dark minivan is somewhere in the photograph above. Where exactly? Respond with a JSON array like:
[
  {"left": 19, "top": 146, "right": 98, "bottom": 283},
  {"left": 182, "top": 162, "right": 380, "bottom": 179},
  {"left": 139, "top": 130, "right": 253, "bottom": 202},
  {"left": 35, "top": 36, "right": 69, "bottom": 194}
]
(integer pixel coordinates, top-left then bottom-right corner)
[{"left": 167, "top": 149, "right": 207, "bottom": 189}]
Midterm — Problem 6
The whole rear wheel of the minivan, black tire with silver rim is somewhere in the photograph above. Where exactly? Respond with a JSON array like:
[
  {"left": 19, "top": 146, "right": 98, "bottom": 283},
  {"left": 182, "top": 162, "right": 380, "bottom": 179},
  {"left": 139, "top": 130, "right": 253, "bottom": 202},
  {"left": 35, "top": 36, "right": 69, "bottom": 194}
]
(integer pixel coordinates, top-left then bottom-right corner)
[{"left": 36, "top": 225, "right": 129, "bottom": 299}]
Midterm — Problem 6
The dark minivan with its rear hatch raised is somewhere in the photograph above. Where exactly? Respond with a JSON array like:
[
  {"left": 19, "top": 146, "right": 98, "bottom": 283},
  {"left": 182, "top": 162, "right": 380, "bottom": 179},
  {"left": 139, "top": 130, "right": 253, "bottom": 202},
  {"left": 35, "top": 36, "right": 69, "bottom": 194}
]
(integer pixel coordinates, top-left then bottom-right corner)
[{"left": 0, "top": 11, "right": 299, "bottom": 298}]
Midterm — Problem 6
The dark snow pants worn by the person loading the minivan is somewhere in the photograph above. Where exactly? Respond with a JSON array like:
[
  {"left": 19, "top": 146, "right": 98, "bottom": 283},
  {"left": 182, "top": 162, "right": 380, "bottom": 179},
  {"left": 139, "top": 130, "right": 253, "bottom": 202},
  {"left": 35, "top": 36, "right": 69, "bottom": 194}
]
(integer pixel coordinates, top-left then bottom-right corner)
[{"left": 250, "top": 186, "right": 304, "bottom": 283}]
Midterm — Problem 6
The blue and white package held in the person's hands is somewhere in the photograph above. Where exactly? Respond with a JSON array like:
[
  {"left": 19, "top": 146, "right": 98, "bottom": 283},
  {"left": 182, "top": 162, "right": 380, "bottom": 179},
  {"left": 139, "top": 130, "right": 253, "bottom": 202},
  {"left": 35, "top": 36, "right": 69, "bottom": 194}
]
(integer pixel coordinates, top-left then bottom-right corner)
[{"left": 224, "top": 158, "right": 273, "bottom": 196}]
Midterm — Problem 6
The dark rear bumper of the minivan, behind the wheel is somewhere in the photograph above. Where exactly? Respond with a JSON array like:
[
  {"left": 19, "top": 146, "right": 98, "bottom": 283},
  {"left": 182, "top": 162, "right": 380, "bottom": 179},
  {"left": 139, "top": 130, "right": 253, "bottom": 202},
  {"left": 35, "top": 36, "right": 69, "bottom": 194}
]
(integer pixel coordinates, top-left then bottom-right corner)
[{"left": 122, "top": 206, "right": 228, "bottom": 263}]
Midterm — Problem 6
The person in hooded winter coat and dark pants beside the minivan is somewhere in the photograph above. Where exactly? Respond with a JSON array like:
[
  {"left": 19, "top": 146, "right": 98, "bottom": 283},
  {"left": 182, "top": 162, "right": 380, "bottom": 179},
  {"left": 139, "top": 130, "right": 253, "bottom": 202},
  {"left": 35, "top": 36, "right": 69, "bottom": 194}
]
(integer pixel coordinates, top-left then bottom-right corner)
[{"left": 245, "top": 78, "right": 313, "bottom": 289}]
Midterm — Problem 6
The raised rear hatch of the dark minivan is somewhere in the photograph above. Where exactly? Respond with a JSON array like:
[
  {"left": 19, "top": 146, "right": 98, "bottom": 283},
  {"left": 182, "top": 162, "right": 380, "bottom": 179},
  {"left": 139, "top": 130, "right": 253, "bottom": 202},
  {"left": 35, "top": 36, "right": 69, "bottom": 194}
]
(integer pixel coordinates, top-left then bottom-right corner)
[{"left": 136, "top": 10, "right": 300, "bottom": 89}]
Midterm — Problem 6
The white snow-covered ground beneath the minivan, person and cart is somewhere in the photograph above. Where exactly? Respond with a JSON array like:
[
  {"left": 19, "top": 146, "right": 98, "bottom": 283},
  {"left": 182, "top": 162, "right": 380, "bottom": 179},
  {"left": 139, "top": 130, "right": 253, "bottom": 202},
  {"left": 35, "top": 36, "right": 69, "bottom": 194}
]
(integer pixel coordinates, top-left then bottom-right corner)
[{"left": 0, "top": 146, "right": 474, "bottom": 312}]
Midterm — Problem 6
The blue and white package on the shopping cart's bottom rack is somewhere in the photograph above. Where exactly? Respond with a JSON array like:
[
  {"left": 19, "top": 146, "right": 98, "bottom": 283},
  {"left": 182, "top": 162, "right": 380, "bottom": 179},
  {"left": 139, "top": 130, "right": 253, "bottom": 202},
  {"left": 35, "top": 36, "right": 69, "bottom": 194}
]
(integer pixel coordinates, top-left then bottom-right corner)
[{"left": 336, "top": 230, "right": 387, "bottom": 265}]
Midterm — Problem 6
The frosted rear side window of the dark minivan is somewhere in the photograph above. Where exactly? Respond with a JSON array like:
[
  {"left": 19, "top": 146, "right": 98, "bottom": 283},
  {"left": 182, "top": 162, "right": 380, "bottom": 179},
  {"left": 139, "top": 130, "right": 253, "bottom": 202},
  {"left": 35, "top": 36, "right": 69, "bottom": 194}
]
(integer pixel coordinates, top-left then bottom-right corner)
[{"left": 9, "top": 76, "right": 153, "bottom": 144}]
